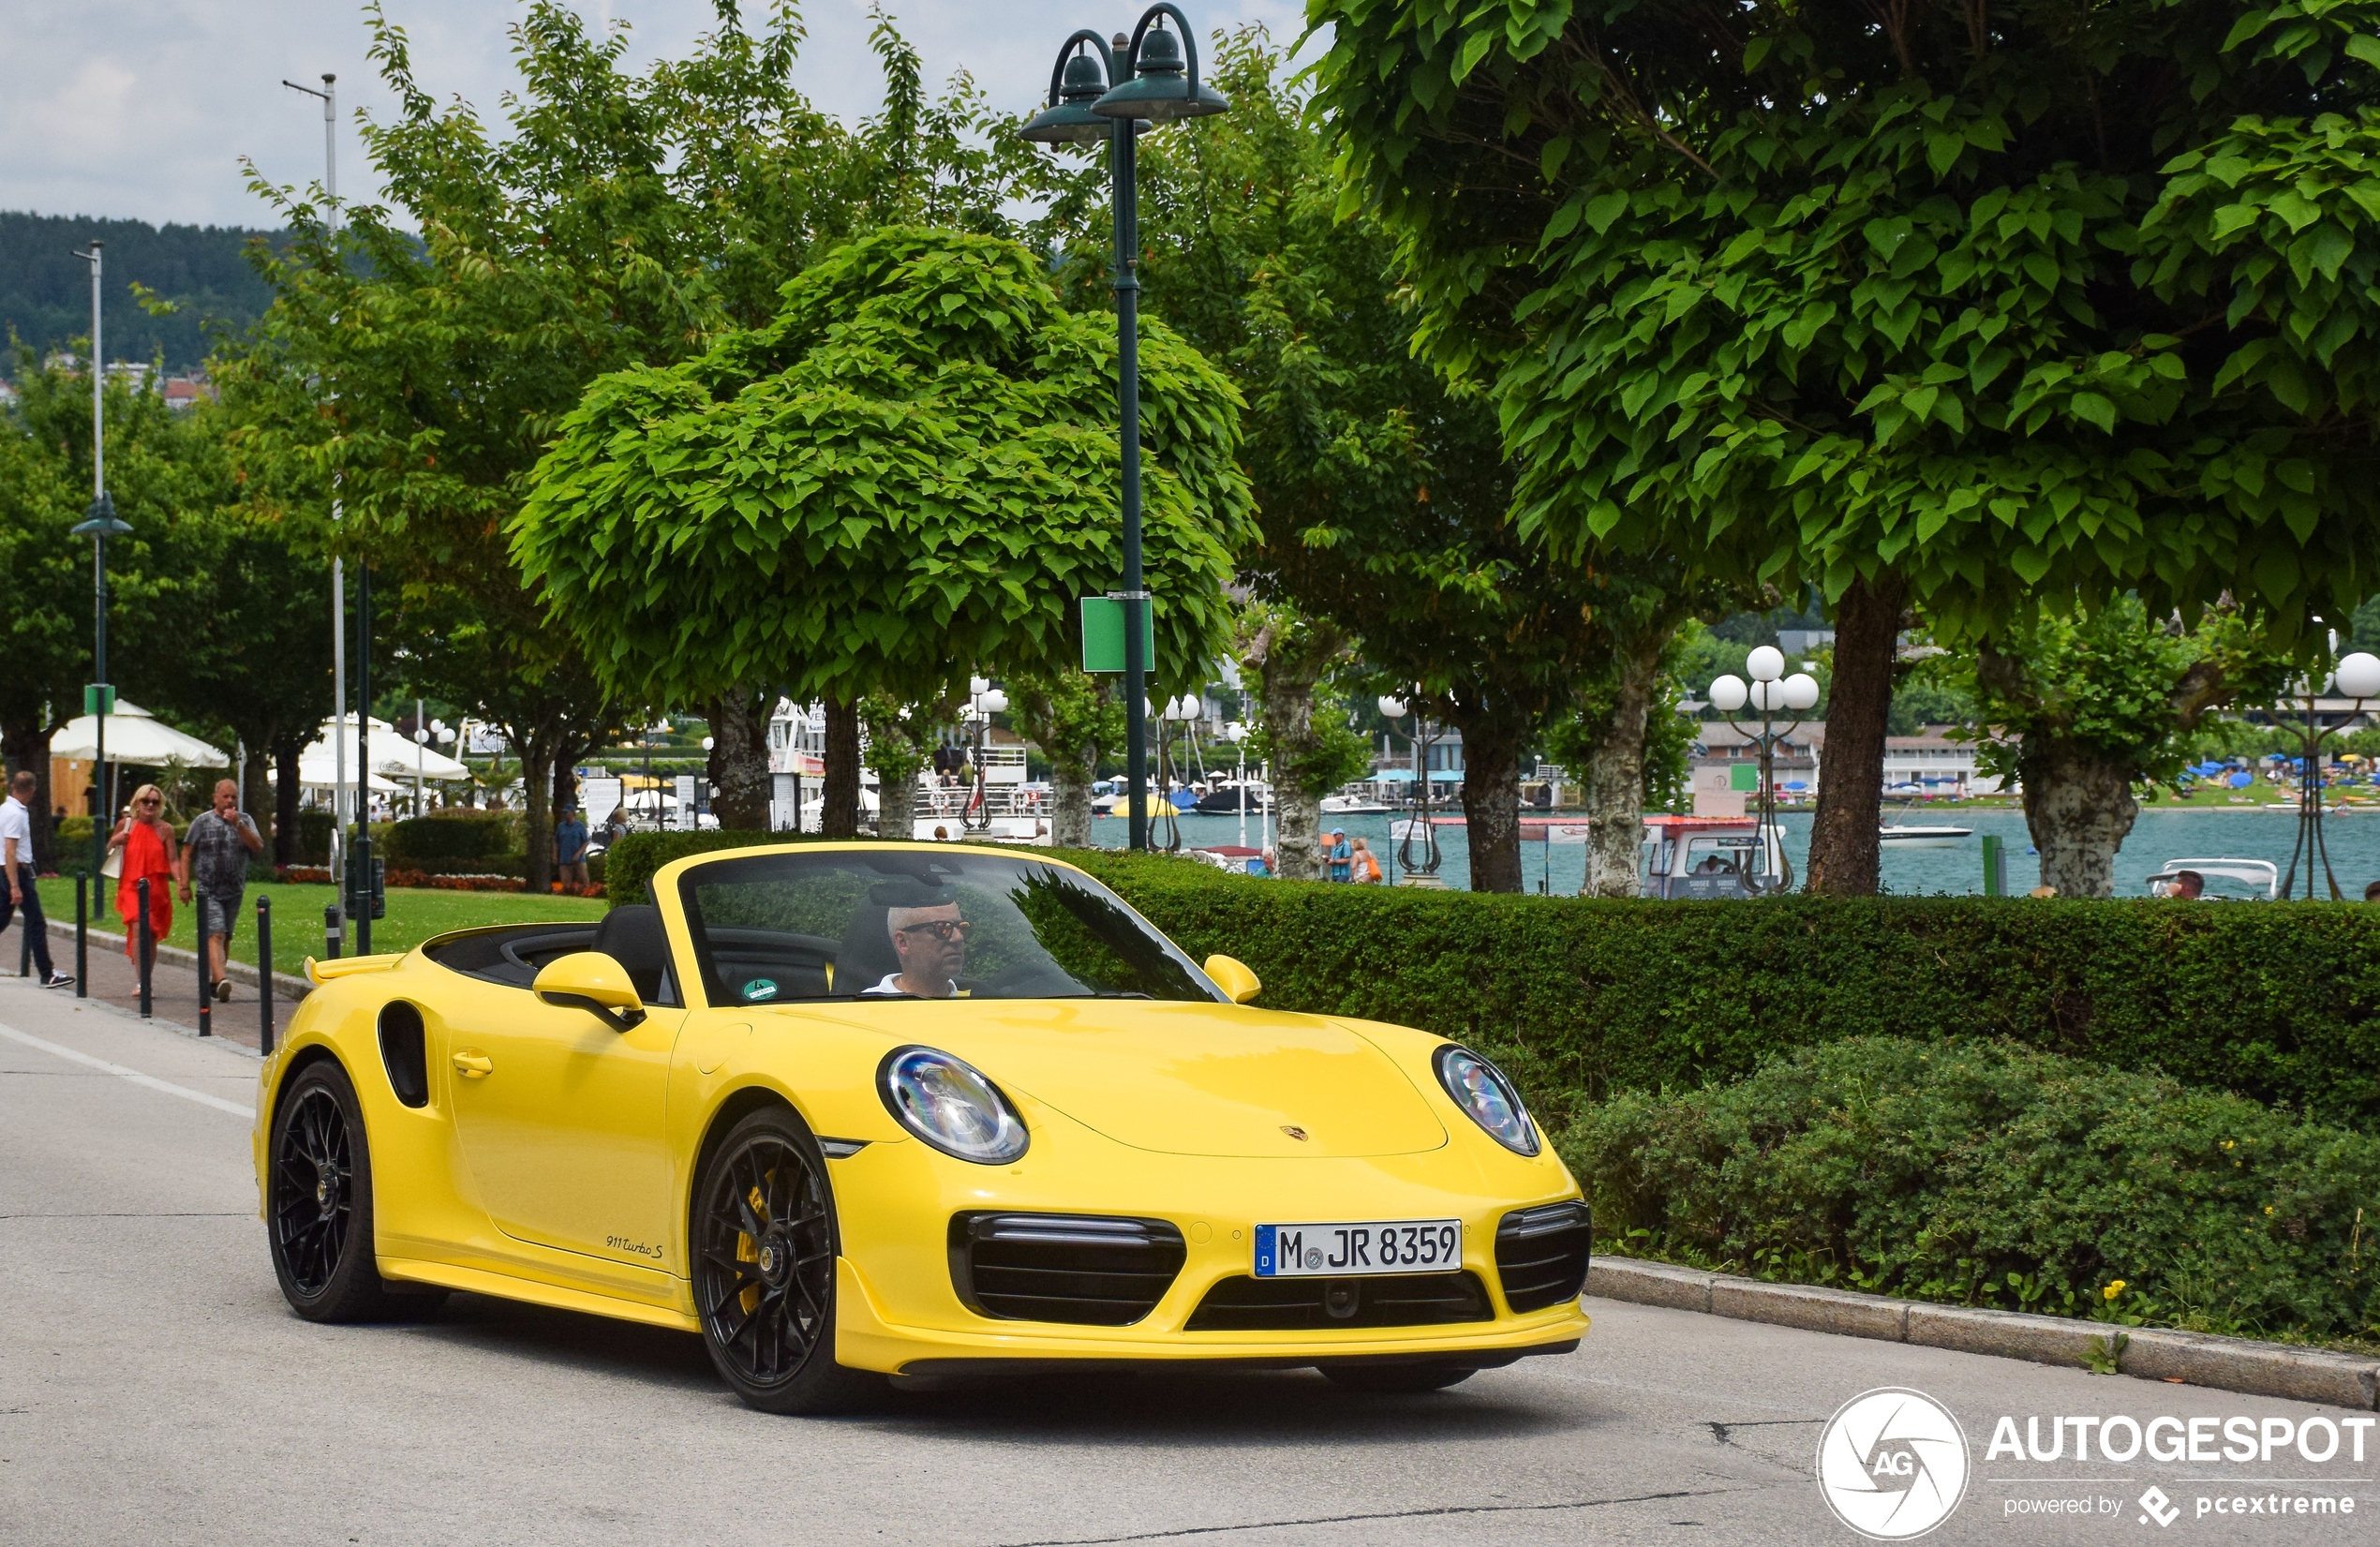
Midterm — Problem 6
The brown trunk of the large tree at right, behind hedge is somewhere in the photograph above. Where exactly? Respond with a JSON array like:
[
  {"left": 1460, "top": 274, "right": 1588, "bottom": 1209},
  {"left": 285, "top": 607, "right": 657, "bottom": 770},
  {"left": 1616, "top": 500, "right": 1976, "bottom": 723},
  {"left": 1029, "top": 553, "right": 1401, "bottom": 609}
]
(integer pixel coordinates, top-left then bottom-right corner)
[{"left": 1808, "top": 573, "right": 1907, "bottom": 898}]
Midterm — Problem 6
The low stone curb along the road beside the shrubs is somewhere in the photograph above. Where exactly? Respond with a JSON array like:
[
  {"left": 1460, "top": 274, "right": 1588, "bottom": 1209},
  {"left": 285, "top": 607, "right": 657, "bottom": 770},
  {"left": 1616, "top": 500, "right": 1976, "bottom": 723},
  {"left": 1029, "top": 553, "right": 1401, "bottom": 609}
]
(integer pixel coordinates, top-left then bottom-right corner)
[{"left": 1587, "top": 1257, "right": 2380, "bottom": 1411}]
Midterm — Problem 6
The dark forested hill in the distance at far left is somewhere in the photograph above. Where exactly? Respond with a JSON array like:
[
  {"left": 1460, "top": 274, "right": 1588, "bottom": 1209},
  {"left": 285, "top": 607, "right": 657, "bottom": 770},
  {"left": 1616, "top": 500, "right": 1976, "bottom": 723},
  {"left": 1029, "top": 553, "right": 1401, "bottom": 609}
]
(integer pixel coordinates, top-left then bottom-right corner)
[{"left": 0, "top": 212, "right": 274, "bottom": 371}]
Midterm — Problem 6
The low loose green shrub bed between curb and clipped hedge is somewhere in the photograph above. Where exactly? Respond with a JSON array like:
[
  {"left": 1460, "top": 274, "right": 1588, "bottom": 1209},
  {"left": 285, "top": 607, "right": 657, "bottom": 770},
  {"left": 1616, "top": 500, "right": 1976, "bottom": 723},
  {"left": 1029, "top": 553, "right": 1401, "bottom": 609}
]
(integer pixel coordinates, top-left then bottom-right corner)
[{"left": 1559, "top": 1037, "right": 2380, "bottom": 1337}]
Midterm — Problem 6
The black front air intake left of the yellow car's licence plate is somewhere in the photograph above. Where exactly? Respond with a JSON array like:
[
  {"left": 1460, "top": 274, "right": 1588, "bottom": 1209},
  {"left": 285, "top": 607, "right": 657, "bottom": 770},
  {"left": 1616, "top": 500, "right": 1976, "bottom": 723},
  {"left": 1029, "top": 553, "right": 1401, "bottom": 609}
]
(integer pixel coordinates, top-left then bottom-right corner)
[{"left": 949, "top": 1213, "right": 1185, "bottom": 1326}]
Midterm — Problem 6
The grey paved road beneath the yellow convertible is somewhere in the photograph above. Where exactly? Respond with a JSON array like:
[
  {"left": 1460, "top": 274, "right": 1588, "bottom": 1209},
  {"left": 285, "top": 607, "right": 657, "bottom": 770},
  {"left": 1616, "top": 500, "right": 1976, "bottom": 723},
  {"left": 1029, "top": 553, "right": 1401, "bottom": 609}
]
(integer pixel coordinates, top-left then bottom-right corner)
[{"left": 0, "top": 983, "right": 2380, "bottom": 1547}]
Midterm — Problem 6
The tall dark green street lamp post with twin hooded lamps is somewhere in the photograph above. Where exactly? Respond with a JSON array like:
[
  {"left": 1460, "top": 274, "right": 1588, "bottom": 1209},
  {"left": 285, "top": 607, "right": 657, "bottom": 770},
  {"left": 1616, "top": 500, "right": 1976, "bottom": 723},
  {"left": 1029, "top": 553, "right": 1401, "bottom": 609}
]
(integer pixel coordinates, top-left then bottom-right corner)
[{"left": 1023, "top": 5, "right": 1230, "bottom": 850}]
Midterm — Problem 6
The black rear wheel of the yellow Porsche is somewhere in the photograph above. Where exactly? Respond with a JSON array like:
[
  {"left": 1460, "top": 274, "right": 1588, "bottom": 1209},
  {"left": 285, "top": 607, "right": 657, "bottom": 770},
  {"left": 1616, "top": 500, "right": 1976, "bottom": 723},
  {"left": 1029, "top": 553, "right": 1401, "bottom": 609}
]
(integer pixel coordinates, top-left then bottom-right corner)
[{"left": 266, "top": 1059, "right": 402, "bottom": 1321}]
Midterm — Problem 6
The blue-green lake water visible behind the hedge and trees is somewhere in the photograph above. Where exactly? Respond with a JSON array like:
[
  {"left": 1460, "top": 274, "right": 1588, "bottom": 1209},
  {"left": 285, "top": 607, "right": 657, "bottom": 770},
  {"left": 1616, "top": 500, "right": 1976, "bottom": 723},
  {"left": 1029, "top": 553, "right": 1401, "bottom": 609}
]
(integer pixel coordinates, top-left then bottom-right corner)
[{"left": 1093, "top": 805, "right": 2380, "bottom": 900}]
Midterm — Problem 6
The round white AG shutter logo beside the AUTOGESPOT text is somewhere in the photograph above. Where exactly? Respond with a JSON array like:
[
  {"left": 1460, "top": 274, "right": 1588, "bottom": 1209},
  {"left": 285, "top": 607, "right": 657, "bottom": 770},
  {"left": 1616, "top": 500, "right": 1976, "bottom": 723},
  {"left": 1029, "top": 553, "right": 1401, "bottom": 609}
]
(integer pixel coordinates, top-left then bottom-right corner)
[{"left": 1819, "top": 1385, "right": 1966, "bottom": 1542}]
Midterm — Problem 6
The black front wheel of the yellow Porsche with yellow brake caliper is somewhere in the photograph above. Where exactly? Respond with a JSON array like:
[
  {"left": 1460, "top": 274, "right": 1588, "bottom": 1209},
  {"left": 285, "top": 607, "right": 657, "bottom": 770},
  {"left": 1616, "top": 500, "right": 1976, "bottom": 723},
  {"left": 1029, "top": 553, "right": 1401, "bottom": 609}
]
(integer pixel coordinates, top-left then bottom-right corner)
[{"left": 692, "top": 1107, "right": 883, "bottom": 1414}]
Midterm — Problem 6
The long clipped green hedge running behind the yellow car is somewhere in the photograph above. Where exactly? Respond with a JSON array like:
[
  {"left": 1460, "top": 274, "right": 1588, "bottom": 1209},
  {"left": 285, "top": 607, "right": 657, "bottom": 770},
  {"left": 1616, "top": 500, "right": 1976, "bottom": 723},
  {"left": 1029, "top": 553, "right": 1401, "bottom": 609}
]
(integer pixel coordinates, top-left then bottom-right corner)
[{"left": 612, "top": 833, "right": 2380, "bottom": 1128}]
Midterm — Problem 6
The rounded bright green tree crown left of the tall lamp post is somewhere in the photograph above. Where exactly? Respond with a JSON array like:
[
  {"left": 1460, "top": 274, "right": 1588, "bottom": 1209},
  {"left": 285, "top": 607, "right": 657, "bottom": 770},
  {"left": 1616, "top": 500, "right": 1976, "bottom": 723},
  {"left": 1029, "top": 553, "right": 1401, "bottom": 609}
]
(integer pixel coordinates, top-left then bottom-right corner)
[{"left": 512, "top": 226, "right": 1247, "bottom": 814}]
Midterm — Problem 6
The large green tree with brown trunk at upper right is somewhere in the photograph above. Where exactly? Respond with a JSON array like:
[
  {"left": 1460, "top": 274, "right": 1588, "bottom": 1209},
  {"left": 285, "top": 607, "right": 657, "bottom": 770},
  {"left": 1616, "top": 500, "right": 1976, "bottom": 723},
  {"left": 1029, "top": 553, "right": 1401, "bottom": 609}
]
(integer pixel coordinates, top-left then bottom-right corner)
[{"left": 1314, "top": 0, "right": 2380, "bottom": 893}]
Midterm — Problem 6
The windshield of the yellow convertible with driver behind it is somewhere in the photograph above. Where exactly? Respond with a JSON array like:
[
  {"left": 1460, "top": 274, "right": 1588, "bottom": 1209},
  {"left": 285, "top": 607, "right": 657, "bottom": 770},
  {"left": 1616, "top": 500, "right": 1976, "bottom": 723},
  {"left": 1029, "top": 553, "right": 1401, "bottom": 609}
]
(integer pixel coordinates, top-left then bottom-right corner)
[{"left": 678, "top": 850, "right": 1224, "bottom": 1004}]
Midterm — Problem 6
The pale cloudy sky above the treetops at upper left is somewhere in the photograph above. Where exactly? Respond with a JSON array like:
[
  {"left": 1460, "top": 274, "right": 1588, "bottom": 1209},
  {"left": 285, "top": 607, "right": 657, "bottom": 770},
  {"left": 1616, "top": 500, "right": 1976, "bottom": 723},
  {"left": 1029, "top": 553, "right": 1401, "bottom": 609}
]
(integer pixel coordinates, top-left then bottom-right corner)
[{"left": 0, "top": 0, "right": 1304, "bottom": 226}]
